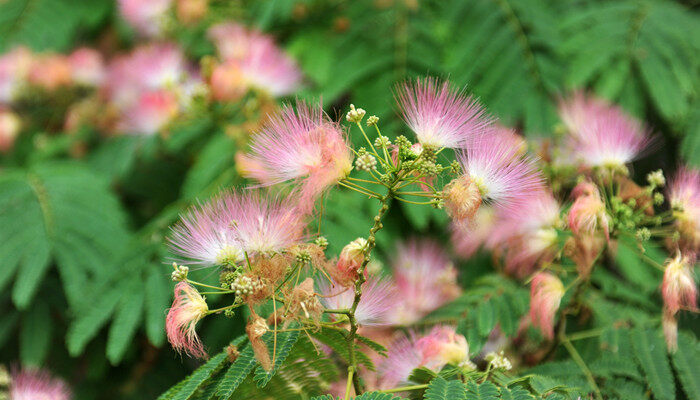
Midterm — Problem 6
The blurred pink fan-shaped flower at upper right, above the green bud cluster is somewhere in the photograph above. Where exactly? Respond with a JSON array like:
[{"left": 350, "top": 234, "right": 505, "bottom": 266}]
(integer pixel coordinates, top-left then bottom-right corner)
[{"left": 559, "top": 93, "right": 652, "bottom": 167}]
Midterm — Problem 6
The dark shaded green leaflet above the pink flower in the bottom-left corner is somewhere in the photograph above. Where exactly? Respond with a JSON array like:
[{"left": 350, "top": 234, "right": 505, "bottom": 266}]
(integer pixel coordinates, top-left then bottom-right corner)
[{"left": 19, "top": 301, "right": 53, "bottom": 367}]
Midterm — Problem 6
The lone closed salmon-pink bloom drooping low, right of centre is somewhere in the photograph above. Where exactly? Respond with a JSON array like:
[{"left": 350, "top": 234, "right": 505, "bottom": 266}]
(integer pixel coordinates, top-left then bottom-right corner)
[{"left": 530, "top": 272, "right": 564, "bottom": 340}]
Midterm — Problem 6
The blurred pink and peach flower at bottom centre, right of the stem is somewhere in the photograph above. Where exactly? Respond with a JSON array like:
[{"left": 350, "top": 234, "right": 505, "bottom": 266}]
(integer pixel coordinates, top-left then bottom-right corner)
[{"left": 378, "top": 325, "right": 473, "bottom": 389}]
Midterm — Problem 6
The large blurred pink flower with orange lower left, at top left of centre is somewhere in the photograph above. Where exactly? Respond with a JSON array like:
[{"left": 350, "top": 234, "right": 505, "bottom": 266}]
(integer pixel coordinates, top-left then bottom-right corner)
[{"left": 209, "top": 23, "right": 302, "bottom": 100}]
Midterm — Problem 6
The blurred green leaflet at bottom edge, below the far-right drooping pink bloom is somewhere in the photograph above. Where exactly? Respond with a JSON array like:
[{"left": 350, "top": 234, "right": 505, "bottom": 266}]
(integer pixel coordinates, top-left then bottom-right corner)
[{"left": 630, "top": 329, "right": 676, "bottom": 400}]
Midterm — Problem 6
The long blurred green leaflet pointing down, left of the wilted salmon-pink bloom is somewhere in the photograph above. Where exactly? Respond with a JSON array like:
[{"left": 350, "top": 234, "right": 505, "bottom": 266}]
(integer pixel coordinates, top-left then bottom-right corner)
[{"left": 107, "top": 282, "right": 144, "bottom": 365}]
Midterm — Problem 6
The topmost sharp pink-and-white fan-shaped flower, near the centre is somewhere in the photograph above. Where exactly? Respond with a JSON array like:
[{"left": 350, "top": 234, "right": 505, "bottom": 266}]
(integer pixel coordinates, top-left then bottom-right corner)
[{"left": 395, "top": 78, "right": 491, "bottom": 148}]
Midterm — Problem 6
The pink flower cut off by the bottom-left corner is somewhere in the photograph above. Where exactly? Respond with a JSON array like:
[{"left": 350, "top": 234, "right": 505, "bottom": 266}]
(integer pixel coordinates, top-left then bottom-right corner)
[{"left": 10, "top": 369, "right": 72, "bottom": 400}]
